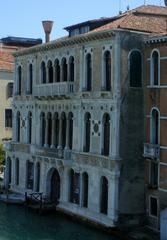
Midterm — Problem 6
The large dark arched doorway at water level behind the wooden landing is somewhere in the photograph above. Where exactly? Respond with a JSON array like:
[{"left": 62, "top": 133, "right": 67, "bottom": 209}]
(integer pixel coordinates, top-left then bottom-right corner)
[{"left": 50, "top": 168, "right": 60, "bottom": 204}]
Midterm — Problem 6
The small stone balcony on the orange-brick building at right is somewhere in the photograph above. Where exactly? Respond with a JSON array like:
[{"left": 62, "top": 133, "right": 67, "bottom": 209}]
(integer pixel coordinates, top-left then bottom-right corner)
[{"left": 143, "top": 143, "right": 160, "bottom": 159}]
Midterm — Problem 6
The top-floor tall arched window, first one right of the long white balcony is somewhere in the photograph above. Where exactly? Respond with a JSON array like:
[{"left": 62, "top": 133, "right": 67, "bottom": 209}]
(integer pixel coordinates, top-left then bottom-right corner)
[{"left": 86, "top": 53, "right": 92, "bottom": 91}]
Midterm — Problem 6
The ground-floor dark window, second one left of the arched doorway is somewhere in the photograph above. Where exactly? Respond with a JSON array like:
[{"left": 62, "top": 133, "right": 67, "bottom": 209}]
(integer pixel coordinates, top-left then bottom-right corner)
[{"left": 26, "top": 160, "right": 34, "bottom": 190}]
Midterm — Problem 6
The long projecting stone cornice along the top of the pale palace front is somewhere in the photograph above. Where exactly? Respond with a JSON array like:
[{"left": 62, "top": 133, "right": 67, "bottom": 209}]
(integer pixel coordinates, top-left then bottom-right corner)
[{"left": 13, "top": 30, "right": 115, "bottom": 57}]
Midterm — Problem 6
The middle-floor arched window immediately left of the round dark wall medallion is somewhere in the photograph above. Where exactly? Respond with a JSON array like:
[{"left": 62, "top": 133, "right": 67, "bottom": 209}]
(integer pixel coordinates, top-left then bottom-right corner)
[{"left": 83, "top": 113, "right": 91, "bottom": 152}]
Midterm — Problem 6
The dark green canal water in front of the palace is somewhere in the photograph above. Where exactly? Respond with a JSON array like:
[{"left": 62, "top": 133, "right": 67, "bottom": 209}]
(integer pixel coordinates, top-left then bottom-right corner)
[{"left": 0, "top": 203, "right": 118, "bottom": 240}]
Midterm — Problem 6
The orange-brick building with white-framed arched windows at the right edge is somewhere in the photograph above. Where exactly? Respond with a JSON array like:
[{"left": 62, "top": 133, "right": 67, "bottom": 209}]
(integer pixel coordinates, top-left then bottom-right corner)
[{"left": 144, "top": 34, "right": 167, "bottom": 229}]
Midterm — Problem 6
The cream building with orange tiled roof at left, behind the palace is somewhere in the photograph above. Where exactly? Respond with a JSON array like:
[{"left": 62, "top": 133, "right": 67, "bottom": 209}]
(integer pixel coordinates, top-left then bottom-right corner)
[{"left": 0, "top": 37, "right": 42, "bottom": 143}]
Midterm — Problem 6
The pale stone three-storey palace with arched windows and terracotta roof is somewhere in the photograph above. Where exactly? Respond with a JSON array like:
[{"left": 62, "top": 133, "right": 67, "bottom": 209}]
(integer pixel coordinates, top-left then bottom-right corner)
[{"left": 5, "top": 6, "right": 167, "bottom": 227}]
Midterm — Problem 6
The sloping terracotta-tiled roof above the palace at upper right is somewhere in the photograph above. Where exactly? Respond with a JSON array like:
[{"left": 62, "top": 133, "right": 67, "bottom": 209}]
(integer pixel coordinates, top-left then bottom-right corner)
[{"left": 93, "top": 6, "right": 167, "bottom": 33}]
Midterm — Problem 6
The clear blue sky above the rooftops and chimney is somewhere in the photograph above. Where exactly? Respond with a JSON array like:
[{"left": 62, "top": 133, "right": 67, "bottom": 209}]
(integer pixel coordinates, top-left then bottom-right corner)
[{"left": 0, "top": 0, "right": 164, "bottom": 39}]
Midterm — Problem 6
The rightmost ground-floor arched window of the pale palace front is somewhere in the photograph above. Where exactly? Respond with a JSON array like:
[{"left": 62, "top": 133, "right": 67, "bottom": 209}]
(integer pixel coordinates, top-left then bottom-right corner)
[{"left": 100, "top": 176, "right": 108, "bottom": 214}]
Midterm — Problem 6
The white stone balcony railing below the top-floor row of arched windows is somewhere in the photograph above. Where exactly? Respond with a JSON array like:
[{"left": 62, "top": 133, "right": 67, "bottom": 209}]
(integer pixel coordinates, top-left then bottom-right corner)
[{"left": 33, "top": 82, "right": 74, "bottom": 97}]
